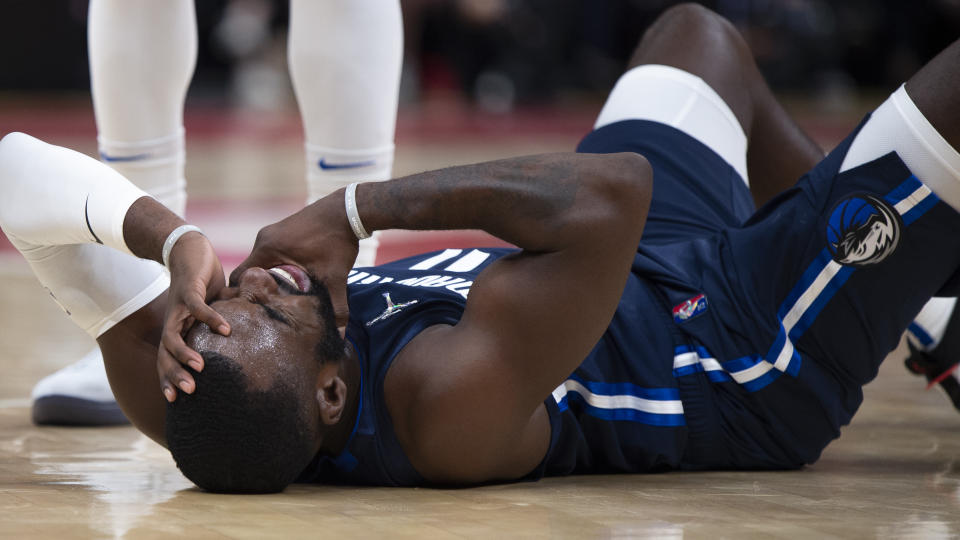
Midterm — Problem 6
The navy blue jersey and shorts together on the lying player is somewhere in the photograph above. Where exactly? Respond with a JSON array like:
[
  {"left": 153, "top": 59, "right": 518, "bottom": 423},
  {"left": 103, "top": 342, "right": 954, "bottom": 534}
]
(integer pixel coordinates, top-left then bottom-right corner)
[{"left": 305, "top": 120, "right": 960, "bottom": 485}]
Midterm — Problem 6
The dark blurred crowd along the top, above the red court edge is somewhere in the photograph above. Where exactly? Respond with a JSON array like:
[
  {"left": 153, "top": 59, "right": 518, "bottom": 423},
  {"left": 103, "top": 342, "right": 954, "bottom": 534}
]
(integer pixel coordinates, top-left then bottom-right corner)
[{"left": 0, "top": 0, "right": 960, "bottom": 109}]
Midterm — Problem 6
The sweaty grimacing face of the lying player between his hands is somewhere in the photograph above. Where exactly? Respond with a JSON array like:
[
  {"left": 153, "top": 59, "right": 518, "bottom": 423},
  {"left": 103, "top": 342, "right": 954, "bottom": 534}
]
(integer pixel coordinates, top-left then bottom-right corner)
[{"left": 186, "top": 265, "right": 335, "bottom": 389}]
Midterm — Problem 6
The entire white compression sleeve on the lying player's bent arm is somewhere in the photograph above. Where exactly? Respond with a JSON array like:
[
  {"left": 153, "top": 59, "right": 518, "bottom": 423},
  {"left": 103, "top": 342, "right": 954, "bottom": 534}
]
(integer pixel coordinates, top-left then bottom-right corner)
[{"left": 0, "top": 133, "right": 170, "bottom": 338}]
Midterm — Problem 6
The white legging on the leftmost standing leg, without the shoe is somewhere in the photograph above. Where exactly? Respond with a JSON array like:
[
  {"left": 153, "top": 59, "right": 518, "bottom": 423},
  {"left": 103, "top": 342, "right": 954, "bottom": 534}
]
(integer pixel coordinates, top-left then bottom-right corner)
[{"left": 87, "top": 0, "right": 197, "bottom": 216}]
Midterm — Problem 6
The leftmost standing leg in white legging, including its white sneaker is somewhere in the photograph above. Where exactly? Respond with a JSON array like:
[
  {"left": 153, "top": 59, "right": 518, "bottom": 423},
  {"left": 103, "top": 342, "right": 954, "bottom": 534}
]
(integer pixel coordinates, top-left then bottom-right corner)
[{"left": 32, "top": 0, "right": 197, "bottom": 425}]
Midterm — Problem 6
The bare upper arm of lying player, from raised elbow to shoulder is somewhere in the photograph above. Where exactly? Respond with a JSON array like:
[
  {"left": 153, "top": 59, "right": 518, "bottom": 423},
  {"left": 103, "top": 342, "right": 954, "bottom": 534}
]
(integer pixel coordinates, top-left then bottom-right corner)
[{"left": 390, "top": 154, "right": 651, "bottom": 481}]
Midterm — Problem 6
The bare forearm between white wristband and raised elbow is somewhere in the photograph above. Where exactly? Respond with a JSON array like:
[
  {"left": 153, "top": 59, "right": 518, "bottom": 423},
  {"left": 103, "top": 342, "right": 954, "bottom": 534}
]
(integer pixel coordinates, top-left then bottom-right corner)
[{"left": 357, "top": 153, "right": 649, "bottom": 251}]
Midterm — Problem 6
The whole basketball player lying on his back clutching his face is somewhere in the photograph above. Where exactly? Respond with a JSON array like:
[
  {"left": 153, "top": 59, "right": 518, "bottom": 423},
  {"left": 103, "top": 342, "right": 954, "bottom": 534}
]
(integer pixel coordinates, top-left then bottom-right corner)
[{"left": 0, "top": 6, "right": 960, "bottom": 492}]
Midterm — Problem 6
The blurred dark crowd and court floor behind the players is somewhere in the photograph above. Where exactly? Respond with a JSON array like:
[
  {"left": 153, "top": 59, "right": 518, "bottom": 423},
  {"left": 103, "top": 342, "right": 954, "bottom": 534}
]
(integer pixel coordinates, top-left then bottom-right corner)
[{"left": 0, "top": 0, "right": 960, "bottom": 260}]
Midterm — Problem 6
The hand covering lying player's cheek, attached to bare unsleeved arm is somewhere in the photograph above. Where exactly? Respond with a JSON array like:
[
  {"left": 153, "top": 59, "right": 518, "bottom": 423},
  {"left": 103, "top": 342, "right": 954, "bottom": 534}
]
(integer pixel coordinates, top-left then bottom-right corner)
[{"left": 230, "top": 192, "right": 358, "bottom": 336}]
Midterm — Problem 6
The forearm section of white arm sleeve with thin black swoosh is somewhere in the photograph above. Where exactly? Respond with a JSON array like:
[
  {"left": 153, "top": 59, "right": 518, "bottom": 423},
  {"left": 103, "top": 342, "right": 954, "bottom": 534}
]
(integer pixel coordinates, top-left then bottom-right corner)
[{"left": 0, "top": 133, "right": 147, "bottom": 253}]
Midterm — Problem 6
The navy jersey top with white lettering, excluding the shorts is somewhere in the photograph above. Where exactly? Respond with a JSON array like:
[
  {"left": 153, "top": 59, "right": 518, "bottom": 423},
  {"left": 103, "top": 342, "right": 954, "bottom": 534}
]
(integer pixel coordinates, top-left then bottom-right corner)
[{"left": 296, "top": 248, "right": 685, "bottom": 485}]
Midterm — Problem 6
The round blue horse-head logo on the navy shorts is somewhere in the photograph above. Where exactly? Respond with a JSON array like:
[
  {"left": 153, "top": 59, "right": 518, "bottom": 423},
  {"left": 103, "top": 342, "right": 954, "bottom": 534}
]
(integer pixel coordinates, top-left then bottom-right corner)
[{"left": 827, "top": 194, "right": 903, "bottom": 266}]
